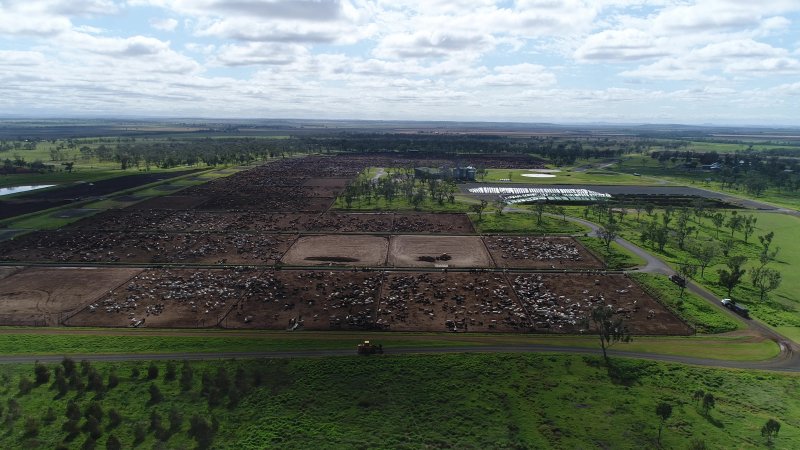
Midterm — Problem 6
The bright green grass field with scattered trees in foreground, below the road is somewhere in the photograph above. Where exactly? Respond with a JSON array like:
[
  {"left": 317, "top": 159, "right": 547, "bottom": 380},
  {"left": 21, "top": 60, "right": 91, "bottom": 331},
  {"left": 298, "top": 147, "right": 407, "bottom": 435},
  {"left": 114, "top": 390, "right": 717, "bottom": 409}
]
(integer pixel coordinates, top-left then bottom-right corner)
[{"left": 0, "top": 354, "right": 800, "bottom": 449}]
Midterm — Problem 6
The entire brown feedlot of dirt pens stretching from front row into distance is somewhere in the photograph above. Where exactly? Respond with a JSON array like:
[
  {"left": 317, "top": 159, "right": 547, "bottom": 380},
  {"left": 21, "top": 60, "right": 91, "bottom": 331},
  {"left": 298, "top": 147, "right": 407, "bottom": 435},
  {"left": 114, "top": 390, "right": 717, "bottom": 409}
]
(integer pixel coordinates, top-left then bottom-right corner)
[{"left": 0, "top": 156, "right": 691, "bottom": 335}]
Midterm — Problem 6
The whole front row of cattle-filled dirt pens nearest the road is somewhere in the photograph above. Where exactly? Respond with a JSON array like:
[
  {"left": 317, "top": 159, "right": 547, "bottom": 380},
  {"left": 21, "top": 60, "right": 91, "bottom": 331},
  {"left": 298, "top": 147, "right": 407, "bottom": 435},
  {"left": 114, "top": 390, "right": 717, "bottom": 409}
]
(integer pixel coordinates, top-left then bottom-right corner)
[{"left": 59, "top": 268, "right": 691, "bottom": 335}]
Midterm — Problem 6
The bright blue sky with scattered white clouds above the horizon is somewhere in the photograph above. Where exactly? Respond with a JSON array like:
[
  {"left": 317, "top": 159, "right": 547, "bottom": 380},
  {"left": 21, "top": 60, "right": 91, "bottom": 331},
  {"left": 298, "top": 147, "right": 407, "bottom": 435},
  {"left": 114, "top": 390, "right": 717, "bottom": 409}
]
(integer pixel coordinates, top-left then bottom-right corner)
[{"left": 0, "top": 0, "right": 800, "bottom": 126}]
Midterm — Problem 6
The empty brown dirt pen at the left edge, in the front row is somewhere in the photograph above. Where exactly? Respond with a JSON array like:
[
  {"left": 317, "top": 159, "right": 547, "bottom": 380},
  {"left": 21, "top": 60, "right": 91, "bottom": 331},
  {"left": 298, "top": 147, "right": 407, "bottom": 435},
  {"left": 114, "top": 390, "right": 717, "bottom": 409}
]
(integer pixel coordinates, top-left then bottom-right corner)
[{"left": 0, "top": 267, "right": 141, "bottom": 326}]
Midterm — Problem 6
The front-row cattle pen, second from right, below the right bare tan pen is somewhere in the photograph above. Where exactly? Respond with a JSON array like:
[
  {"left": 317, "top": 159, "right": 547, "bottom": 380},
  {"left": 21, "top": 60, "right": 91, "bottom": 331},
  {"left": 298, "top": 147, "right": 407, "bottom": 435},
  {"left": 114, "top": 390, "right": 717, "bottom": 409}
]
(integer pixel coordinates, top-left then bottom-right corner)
[{"left": 377, "top": 272, "right": 529, "bottom": 332}]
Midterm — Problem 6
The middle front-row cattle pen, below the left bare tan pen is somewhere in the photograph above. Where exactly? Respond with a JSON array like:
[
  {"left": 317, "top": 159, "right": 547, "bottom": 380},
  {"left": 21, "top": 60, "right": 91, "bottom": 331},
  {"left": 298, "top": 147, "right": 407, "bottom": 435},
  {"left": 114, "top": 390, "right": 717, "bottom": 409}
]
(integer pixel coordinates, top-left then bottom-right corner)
[{"left": 222, "top": 270, "right": 383, "bottom": 330}]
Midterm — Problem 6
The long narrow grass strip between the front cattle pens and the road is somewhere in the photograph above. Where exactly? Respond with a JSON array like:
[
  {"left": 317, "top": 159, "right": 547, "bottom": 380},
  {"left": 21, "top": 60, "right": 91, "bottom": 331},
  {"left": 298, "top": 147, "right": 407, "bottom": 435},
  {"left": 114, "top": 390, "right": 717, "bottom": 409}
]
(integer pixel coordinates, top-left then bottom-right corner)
[{"left": 0, "top": 328, "right": 778, "bottom": 360}]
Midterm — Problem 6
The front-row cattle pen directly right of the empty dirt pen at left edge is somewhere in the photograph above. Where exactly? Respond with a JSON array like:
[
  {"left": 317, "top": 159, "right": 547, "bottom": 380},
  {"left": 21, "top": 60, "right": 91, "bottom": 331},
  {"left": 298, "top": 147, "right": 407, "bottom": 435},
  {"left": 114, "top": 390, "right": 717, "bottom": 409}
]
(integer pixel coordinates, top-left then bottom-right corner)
[{"left": 65, "top": 269, "right": 267, "bottom": 328}]
